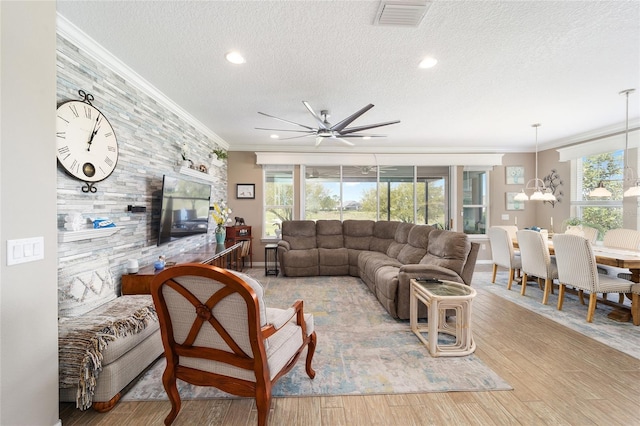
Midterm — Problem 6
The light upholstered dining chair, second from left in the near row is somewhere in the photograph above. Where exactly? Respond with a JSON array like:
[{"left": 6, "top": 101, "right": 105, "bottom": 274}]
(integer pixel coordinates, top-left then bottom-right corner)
[{"left": 517, "top": 229, "right": 558, "bottom": 305}]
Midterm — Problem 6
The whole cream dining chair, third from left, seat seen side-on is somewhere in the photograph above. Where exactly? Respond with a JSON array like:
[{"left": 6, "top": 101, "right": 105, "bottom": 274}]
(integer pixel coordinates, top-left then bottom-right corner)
[{"left": 553, "top": 234, "right": 633, "bottom": 322}]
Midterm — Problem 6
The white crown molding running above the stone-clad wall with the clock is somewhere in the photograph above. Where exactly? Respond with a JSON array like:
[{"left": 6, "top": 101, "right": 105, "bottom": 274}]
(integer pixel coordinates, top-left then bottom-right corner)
[{"left": 56, "top": 13, "right": 229, "bottom": 149}]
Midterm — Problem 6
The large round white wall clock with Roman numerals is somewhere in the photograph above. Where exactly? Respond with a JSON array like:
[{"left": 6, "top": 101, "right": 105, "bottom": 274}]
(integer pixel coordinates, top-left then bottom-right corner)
[{"left": 56, "top": 90, "right": 118, "bottom": 192}]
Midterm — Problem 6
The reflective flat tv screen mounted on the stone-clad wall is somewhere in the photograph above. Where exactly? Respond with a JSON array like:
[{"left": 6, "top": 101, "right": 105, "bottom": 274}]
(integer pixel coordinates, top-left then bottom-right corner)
[{"left": 158, "top": 175, "right": 211, "bottom": 245}]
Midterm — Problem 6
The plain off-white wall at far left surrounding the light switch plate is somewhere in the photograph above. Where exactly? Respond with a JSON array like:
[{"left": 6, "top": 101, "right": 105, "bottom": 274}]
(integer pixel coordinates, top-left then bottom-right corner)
[{"left": 0, "top": 1, "right": 58, "bottom": 425}]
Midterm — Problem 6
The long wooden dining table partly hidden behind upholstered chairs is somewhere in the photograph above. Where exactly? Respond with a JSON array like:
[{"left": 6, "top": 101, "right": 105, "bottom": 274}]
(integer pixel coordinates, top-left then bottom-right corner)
[{"left": 513, "top": 235, "right": 640, "bottom": 326}]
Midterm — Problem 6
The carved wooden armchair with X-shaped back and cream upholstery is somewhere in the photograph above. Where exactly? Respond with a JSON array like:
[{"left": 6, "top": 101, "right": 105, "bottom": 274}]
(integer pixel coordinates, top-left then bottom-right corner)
[{"left": 151, "top": 263, "right": 316, "bottom": 425}]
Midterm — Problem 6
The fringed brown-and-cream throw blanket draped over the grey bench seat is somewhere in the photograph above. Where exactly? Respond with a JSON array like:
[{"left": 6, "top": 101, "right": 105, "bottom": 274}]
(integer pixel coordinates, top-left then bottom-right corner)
[{"left": 58, "top": 295, "right": 158, "bottom": 410}]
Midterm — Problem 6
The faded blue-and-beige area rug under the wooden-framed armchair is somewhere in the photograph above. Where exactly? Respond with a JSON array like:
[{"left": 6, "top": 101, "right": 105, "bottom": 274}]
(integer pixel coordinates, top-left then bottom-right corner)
[{"left": 123, "top": 269, "right": 512, "bottom": 401}]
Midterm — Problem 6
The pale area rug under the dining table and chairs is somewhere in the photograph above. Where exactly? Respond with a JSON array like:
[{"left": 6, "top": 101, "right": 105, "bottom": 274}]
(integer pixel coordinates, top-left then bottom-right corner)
[{"left": 472, "top": 270, "right": 640, "bottom": 359}]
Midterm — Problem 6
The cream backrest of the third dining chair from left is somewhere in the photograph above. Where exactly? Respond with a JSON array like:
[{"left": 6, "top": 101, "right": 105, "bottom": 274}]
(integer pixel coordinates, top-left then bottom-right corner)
[{"left": 553, "top": 234, "right": 598, "bottom": 292}]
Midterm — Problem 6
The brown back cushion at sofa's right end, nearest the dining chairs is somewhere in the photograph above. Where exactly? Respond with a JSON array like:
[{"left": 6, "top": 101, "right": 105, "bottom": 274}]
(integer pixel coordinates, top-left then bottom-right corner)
[{"left": 420, "top": 229, "right": 471, "bottom": 275}]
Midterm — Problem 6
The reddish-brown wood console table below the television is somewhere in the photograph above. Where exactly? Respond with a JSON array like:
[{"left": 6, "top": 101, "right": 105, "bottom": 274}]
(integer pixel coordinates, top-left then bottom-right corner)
[{"left": 122, "top": 243, "right": 242, "bottom": 295}]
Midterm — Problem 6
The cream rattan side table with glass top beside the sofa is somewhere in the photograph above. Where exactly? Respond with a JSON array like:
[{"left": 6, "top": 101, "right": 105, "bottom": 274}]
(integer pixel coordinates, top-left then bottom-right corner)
[{"left": 409, "top": 280, "right": 476, "bottom": 357}]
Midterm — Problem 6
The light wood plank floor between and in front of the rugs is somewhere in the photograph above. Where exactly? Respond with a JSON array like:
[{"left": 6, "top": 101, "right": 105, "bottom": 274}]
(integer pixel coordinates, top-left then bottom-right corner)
[{"left": 60, "top": 265, "right": 640, "bottom": 426}]
